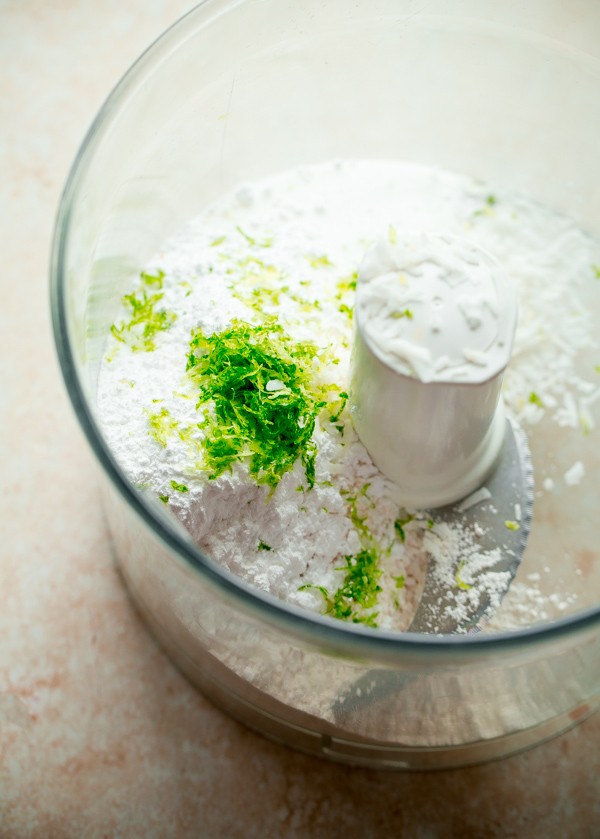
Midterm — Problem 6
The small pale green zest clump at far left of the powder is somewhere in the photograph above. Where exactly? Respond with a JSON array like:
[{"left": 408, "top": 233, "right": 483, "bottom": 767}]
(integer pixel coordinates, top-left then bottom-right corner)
[{"left": 110, "top": 271, "right": 177, "bottom": 352}]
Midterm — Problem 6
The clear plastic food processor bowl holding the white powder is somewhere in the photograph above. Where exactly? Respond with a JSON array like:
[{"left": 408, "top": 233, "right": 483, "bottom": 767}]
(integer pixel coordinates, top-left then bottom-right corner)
[{"left": 52, "top": 0, "right": 600, "bottom": 769}]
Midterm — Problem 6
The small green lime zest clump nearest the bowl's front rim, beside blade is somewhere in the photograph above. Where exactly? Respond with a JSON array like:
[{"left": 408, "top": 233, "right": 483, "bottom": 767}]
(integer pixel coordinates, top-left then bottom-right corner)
[{"left": 300, "top": 549, "right": 382, "bottom": 627}]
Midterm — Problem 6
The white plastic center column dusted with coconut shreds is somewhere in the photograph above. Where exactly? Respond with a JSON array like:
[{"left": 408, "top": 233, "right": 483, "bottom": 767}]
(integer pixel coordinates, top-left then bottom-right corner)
[{"left": 350, "top": 233, "right": 517, "bottom": 508}]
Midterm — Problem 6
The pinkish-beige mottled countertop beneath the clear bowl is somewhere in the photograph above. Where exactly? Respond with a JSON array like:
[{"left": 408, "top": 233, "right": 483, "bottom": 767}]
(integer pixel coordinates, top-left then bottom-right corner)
[{"left": 0, "top": 0, "right": 600, "bottom": 839}]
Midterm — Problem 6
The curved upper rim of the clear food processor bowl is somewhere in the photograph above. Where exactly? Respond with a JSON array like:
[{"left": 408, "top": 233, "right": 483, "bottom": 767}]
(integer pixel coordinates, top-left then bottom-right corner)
[{"left": 50, "top": 0, "right": 600, "bottom": 661}]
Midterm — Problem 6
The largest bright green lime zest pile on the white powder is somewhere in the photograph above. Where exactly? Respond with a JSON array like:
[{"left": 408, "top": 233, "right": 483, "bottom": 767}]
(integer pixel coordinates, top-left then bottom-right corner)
[{"left": 187, "top": 318, "right": 327, "bottom": 489}]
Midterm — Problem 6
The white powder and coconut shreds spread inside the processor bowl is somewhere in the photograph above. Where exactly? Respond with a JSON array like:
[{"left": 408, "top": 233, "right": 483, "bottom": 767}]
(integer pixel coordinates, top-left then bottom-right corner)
[{"left": 98, "top": 161, "right": 600, "bottom": 630}]
